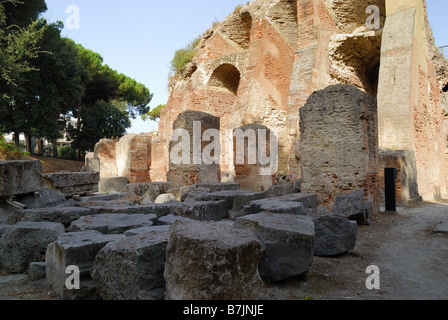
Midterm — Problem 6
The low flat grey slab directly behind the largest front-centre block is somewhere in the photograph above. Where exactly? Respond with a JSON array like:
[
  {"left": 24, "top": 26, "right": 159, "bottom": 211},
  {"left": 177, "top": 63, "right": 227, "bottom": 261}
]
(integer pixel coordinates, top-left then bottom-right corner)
[{"left": 170, "top": 200, "right": 229, "bottom": 221}]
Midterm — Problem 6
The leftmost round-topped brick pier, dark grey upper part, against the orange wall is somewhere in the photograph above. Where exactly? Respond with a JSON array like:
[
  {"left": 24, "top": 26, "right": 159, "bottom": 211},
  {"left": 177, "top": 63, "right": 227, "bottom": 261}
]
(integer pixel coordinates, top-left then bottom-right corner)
[{"left": 167, "top": 111, "right": 221, "bottom": 188}]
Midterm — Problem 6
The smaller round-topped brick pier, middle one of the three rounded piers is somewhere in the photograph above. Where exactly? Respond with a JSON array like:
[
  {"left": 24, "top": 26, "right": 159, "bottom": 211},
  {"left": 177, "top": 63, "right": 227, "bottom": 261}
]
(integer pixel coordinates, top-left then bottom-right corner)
[{"left": 233, "top": 124, "right": 278, "bottom": 192}]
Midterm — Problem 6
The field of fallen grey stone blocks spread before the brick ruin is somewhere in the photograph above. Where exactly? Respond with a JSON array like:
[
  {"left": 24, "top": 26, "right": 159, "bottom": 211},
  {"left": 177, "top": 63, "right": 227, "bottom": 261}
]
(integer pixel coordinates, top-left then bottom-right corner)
[{"left": 0, "top": 161, "right": 364, "bottom": 300}]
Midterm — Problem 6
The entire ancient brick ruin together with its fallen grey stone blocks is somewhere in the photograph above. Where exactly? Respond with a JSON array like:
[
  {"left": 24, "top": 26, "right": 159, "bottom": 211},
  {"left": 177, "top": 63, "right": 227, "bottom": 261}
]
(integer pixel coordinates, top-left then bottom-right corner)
[{"left": 0, "top": 0, "right": 448, "bottom": 300}]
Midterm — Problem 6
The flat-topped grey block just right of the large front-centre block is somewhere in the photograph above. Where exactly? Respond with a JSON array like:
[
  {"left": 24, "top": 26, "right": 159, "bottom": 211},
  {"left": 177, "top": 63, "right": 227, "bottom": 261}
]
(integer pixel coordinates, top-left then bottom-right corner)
[{"left": 235, "top": 212, "right": 315, "bottom": 282}]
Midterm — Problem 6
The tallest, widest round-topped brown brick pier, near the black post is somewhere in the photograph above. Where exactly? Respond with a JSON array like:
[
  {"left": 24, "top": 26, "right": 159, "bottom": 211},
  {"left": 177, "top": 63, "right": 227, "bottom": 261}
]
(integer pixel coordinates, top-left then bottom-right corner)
[{"left": 300, "top": 85, "right": 379, "bottom": 211}]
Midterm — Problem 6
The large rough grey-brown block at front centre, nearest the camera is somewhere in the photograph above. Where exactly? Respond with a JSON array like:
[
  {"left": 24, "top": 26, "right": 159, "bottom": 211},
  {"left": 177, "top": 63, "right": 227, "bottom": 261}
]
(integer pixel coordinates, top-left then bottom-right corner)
[{"left": 165, "top": 221, "right": 262, "bottom": 300}]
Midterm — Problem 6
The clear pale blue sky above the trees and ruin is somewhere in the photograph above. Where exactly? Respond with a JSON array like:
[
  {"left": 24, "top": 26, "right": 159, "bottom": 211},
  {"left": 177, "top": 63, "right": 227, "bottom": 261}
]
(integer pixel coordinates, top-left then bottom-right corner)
[{"left": 44, "top": 0, "right": 448, "bottom": 133}]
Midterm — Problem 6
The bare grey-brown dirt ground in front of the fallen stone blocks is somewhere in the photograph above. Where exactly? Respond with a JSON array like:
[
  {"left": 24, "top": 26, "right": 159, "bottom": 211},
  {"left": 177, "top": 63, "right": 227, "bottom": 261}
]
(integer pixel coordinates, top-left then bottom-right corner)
[{"left": 0, "top": 201, "right": 448, "bottom": 300}]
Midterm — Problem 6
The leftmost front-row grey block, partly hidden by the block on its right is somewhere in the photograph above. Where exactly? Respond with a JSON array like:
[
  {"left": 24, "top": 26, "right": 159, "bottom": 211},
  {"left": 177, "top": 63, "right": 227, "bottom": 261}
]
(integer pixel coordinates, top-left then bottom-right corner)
[{"left": 45, "top": 231, "right": 124, "bottom": 300}]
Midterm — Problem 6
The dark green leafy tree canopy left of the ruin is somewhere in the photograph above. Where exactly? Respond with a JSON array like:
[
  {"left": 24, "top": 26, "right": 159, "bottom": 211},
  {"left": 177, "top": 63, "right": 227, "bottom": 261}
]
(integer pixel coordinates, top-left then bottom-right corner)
[{"left": 0, "top": 0, "right": 153, "bottom": 155}]
